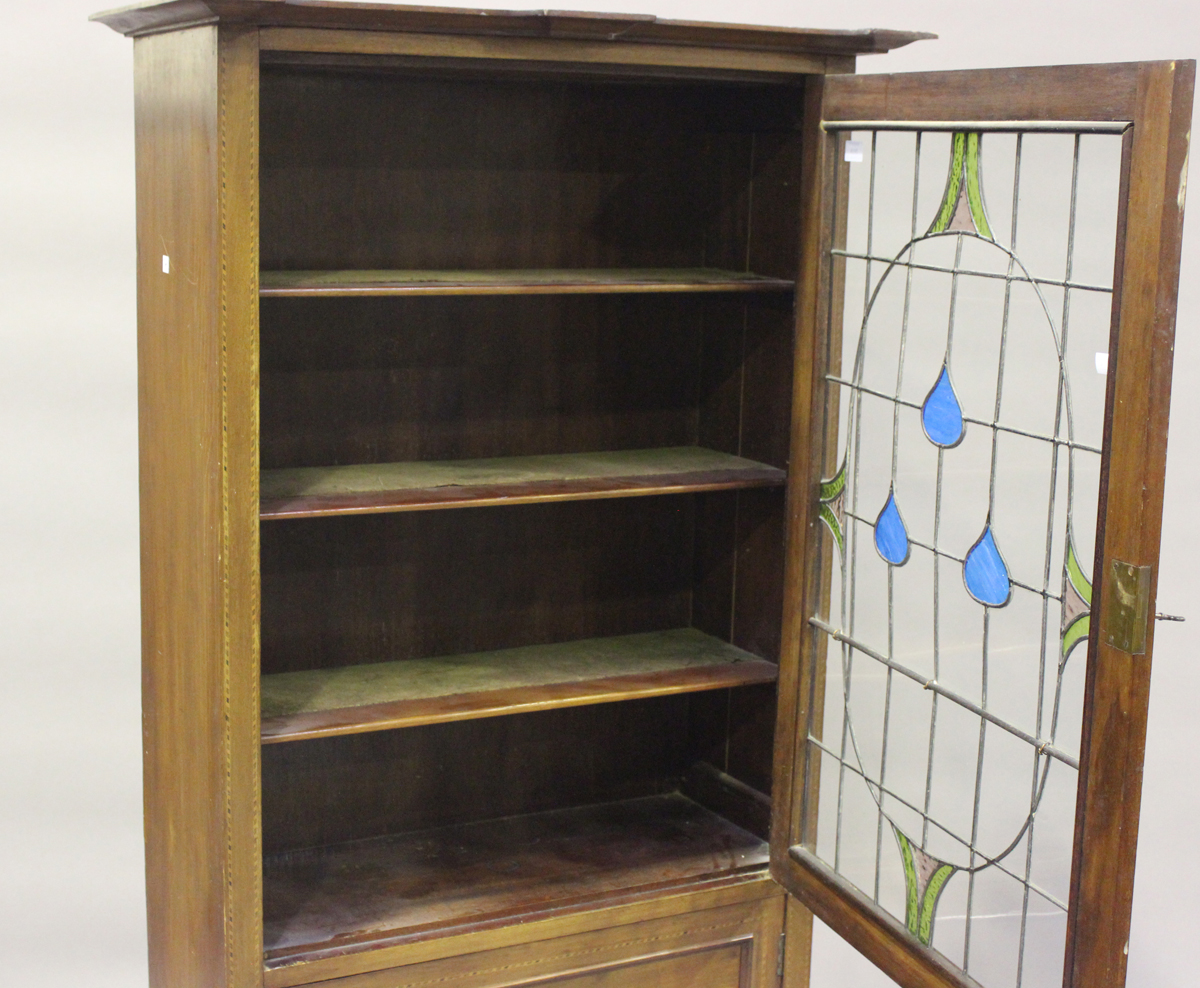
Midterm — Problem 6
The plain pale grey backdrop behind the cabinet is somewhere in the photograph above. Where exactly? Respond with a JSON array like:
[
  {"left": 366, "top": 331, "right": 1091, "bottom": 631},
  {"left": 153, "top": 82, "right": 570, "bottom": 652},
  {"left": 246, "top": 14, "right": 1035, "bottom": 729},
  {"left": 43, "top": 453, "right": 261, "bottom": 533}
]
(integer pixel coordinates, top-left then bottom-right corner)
[{"left": 0, "top": 0, "right": 1200, "bottom": 988}]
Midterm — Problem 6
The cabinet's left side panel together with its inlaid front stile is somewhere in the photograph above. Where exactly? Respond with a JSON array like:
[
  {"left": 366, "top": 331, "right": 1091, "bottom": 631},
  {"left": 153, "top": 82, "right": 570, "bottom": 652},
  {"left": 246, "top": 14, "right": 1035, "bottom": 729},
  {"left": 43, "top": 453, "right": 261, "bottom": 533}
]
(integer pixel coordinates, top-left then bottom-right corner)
[{"left": 134, "top": 28, "right": 262, "bottom": 988}]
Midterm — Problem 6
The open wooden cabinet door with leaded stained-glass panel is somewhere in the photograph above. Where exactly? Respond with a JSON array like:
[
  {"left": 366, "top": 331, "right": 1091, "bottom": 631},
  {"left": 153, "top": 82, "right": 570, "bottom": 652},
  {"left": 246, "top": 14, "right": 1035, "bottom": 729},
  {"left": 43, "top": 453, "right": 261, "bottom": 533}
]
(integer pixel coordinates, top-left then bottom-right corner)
[{"left": 772, "top": 62, "right": 1195, "bottom": 988}]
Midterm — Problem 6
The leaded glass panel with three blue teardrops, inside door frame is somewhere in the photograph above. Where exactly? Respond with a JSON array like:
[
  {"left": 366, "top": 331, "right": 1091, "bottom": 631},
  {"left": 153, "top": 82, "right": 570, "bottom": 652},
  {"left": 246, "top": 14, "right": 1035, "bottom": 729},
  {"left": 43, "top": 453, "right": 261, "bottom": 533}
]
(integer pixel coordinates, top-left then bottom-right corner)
[{"left": 806, "top": 132, "right": 1121, "bottom": 988}]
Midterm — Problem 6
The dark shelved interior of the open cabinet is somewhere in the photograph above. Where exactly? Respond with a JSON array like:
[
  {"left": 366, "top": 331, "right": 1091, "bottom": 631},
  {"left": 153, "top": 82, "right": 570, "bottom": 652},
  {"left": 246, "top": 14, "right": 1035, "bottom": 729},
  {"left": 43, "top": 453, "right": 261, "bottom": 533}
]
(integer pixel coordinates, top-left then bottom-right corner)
[{"left": 260, "top": 59, "right": 803, "bottom": 965}]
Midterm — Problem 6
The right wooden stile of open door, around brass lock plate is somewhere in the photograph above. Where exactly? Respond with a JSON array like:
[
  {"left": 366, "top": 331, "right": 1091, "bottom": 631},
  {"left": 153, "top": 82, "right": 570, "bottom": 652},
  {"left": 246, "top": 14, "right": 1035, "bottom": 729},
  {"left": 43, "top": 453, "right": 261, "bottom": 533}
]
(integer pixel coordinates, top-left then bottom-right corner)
[{"left": 1063, "top": 61, "right": 1195, "bottom": 988}]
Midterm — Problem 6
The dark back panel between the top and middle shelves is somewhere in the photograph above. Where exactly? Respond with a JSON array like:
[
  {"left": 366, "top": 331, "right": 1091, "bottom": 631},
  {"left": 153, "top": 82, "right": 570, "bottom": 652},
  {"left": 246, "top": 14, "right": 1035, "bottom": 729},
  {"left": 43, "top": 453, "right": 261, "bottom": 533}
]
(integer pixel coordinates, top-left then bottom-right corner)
[{"left": 262, "top": 295, "right": 705, "bottom": 468}]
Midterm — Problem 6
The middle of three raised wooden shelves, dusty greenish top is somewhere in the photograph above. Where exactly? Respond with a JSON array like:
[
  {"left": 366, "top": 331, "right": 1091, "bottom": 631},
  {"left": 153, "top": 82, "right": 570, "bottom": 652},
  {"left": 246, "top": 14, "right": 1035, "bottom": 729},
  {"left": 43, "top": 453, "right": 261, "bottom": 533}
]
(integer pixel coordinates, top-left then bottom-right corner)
[{"left": 259, "top": 447, "right": 787, "bottom": 519}]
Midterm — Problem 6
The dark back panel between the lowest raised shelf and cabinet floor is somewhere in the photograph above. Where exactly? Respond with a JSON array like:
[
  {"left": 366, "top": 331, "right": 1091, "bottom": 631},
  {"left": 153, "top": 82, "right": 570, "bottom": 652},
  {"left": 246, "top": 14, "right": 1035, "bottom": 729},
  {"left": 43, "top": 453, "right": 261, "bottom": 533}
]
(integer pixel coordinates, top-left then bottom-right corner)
[{"left": 263, "top": 696, "right": 689, "bottom": 854}]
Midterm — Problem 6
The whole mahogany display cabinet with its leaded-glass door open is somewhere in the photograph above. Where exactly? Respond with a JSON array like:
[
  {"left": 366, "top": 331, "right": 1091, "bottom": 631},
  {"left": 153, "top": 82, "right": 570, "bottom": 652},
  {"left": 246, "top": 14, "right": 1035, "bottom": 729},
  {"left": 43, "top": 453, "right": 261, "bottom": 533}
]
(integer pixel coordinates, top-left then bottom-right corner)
[{"left": 97, "top": 0, "right": 1194, "bottom": 988}]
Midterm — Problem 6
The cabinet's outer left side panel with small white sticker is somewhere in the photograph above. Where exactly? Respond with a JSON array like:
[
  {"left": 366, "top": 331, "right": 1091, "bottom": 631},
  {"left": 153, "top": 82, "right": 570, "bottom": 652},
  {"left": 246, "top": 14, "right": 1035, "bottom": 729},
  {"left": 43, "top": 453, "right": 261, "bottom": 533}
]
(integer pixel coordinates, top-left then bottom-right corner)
[{"left": 134, "top": 28, "right": 227, "bottom": 988}]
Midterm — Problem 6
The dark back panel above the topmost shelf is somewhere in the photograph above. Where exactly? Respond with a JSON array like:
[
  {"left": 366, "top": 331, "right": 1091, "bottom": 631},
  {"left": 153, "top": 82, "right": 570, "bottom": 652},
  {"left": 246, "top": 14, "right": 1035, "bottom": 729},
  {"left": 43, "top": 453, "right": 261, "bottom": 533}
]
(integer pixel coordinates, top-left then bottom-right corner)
[{"left": 262, "top": 66, "right": 802, "bottom": 270}]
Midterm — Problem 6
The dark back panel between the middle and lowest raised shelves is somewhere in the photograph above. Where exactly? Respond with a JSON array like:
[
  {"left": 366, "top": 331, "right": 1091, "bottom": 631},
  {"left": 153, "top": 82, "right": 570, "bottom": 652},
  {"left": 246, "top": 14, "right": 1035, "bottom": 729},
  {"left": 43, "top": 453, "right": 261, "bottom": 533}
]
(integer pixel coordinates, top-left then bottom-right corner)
[{"left": 262, "top": 496, "right": 695, "bottom": 673}]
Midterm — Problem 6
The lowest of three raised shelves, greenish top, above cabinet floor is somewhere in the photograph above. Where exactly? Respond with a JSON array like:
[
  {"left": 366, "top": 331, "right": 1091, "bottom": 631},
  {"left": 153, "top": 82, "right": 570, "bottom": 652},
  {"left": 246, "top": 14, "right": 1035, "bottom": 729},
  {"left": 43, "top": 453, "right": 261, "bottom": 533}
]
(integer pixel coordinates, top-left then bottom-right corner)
[{"left": 262, "top": 628, "right": 778, "bottom": 744}]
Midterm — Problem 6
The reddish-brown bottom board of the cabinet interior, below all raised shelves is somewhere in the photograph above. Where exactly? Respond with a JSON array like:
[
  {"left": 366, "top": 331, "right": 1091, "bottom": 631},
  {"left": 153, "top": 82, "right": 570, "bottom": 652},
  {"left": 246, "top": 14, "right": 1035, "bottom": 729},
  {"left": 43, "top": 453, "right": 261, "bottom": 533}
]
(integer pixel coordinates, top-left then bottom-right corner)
[{"left": 263, "top": 794, "right": 768, "bottom": 968}]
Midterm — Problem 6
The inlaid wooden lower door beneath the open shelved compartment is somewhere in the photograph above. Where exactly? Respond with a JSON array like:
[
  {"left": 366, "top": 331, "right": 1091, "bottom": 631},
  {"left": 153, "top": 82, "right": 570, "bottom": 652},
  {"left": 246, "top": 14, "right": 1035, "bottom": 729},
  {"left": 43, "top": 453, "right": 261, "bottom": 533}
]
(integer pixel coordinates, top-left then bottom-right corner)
[{"left": 288, "top": 894, "right": 784, "bottom": 988}]
